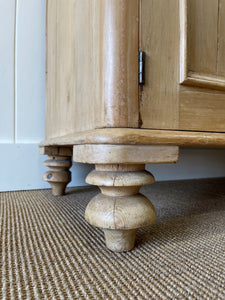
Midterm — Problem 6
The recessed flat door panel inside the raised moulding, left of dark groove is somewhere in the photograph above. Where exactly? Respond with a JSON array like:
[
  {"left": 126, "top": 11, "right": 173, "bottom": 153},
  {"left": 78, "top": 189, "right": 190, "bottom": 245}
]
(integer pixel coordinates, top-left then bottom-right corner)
[{"left": 187, "top": 0, "right": 218, "bottom": 75}]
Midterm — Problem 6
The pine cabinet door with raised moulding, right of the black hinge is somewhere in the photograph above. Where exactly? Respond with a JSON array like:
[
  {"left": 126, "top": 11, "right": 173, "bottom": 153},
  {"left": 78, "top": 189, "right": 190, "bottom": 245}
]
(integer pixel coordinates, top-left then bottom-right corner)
[{"left": 139, "top": 0, "right": 225, "bottom": 132}]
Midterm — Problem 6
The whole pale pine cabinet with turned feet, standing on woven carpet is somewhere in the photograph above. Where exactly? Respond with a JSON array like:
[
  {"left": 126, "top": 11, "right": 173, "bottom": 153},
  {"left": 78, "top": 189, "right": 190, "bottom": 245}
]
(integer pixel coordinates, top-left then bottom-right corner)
[{"left": 40, "top": 0, "right": 225, "bottom": 251}]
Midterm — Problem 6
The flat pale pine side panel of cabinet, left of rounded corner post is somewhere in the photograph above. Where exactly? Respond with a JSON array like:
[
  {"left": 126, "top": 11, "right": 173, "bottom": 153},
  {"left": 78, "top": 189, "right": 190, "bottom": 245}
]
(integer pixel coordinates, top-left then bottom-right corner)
[{"left": 46, "top": 0, "right": 104, "bottom": 138}]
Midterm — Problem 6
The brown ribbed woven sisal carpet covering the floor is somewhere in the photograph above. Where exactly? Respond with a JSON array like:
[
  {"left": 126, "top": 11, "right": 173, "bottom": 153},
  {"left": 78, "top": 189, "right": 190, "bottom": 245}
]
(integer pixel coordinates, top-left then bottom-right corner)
[{"left": 0, "top": 179, "right": 225, "bottom": 300}]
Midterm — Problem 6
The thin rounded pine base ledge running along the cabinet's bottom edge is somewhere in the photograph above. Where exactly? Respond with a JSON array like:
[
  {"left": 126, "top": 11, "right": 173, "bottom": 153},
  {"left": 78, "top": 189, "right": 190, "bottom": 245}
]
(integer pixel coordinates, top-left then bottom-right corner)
[{"left": 40, "top": 128, "right": 225, "bottom": 149}]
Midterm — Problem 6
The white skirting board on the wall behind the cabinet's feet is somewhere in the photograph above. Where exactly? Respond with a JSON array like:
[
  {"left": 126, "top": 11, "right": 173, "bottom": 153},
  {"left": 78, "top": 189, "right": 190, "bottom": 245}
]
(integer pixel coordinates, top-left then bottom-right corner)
[{"left": 0, "top": 144, "right": 225, "bottom": 192}]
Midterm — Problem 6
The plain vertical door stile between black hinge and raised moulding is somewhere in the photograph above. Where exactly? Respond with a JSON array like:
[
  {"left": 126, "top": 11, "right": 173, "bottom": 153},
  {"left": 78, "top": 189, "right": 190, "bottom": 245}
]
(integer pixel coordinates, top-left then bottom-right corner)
[{"left": 140, "top": 0, "right": 180, "bottom": 129}]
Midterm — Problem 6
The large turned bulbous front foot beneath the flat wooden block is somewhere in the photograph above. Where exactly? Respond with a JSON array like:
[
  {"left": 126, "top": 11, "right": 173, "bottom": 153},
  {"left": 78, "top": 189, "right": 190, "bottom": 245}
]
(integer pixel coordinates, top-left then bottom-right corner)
[{"left": 85, "top": 165, "right": 156, "bottom": 252}]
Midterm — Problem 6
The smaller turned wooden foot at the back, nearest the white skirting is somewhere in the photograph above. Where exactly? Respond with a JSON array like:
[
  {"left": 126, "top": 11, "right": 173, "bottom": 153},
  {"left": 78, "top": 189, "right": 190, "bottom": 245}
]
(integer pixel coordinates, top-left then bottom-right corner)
[{"left": 43, "top": 156, "right": 72, "bottom": 196}]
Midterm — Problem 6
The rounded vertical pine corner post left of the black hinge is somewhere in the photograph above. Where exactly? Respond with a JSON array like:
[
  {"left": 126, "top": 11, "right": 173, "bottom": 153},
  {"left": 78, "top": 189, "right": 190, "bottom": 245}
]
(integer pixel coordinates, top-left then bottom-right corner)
[{"left": 101, "top": 0, "right": 139, "bottom": 127}]
